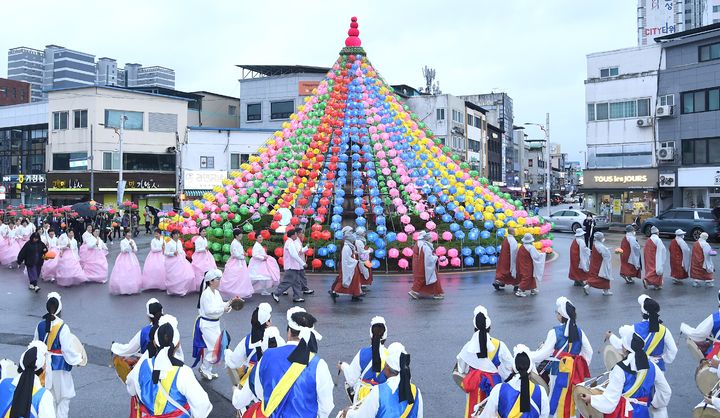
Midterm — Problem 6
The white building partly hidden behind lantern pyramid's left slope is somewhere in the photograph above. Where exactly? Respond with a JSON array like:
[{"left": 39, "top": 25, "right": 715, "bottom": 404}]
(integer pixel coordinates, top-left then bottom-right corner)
[{"left": 179, "top": 127, "right": 274, "bottom": 199}]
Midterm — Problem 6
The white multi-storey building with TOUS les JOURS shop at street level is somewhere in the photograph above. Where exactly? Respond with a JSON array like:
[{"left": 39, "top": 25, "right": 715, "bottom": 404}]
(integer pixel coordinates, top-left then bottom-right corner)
[{"left": 583, "top": 45, "right": 660, "bottom": 223}]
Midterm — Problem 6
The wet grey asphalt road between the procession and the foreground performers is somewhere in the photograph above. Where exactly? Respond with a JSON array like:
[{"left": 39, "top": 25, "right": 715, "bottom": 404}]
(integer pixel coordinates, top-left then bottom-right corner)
[{"left": 0, "top": 233, "right": 718, "bottom": 418}]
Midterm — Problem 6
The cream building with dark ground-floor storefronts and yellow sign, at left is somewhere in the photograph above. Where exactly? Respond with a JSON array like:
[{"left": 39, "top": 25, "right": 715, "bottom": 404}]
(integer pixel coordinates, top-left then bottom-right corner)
[{"left": 45, "top": 87, "right": 187, "bottom": 209}]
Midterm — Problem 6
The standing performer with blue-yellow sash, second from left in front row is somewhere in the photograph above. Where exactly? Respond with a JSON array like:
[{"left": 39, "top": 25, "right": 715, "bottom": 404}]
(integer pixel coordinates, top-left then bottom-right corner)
[{"left": 33, "top": 294, "right": 83, "bottom": 418}]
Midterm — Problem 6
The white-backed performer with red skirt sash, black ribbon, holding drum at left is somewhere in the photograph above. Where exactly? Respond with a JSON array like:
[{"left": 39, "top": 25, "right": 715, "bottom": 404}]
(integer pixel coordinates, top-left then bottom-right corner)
[{"left": 457, "top": 305, "right": 513, "bottom": 418}]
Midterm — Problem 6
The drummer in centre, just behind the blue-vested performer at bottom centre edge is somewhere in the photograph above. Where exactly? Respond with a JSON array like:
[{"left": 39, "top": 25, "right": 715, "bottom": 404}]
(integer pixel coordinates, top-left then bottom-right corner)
[{"left": 337, "top": 316, "right": 388, "bottom": 404}]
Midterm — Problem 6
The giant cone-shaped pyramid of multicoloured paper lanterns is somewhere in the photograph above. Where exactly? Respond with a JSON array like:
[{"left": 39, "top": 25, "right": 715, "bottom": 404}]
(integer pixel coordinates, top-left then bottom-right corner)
[{"left": 162, "top": 17, "right": 552, "bottom": 269}]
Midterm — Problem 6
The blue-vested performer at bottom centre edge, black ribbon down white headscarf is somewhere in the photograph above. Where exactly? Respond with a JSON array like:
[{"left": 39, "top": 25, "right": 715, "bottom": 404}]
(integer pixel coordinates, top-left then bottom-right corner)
[{"left": 340, "top": 343, "right": 424, "bottom": 418}]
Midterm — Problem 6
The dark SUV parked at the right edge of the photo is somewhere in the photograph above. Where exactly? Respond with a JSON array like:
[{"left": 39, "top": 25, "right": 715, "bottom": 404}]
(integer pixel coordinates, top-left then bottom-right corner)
[{"left": 641, "top": 208, "right": 720, "bottom": 240}]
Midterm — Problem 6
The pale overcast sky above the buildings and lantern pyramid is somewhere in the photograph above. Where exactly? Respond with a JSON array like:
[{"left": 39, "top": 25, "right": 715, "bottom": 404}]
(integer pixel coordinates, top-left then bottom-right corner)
[{"left": 0, "top": 0, "right": 637, "bottom": 166}]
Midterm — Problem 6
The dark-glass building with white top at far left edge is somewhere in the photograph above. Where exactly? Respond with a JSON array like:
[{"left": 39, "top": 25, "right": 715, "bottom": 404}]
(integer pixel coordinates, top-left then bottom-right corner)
[{"left": 0, "top": 102, "right": 48, "bottom": 205}]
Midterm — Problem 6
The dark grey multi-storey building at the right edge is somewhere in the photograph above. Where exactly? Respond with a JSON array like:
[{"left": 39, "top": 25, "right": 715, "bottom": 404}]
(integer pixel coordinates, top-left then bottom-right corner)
[{"left": 657, "top": 24, "right": 720, "bottom": 208}]
